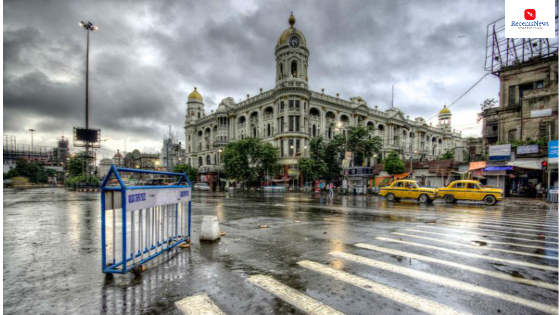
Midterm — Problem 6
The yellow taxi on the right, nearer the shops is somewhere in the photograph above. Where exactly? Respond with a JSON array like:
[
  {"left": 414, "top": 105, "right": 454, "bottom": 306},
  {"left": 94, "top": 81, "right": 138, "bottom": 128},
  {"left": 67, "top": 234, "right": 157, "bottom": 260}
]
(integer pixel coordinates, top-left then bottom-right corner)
[{"left": 437, "top": 180, "right": 504, "bottom": 205}]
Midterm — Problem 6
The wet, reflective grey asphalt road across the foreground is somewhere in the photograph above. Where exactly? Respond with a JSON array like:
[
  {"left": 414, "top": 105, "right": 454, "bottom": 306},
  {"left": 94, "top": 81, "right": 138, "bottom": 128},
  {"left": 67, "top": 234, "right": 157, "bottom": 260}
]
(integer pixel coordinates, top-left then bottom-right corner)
[{"left": 3, "top": 189, "right": 558, "bottom": 315}]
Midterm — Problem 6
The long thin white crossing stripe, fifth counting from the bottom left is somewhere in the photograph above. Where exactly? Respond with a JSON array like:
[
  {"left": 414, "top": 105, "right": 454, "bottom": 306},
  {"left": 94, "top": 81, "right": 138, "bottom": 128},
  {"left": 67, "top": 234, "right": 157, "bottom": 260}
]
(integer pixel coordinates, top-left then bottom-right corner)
[{"left": 354, "top": 243, "right": 558, "bottom": 291}]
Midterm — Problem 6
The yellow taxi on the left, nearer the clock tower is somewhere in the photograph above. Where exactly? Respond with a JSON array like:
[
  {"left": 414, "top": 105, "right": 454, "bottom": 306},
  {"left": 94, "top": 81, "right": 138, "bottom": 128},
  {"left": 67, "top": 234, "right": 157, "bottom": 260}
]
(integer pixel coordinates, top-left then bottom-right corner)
[{"left": 379, "top": 180, "right": 437, "bottom": 203}]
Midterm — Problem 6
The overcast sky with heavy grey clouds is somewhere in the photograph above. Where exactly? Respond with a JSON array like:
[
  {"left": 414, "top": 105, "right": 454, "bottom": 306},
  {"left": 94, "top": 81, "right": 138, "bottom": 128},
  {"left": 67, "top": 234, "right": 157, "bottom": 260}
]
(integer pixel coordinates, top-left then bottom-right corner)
[{"left": 3, "top": 0, "right": 504, "bottom": 157}]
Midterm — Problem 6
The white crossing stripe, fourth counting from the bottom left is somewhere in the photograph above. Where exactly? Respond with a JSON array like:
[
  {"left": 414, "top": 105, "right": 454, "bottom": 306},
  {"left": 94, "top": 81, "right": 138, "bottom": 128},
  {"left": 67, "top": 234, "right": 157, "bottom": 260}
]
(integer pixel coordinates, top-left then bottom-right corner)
[{"left": 330, "top": 252, "right": 558, "bottom": 315}]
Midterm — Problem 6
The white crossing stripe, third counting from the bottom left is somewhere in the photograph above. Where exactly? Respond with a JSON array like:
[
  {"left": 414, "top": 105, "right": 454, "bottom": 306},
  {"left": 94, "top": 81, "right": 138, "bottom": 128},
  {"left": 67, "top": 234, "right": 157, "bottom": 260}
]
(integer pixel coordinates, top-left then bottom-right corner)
[{"left": 298, "top": 260, "right": 470, "bottom": 315}]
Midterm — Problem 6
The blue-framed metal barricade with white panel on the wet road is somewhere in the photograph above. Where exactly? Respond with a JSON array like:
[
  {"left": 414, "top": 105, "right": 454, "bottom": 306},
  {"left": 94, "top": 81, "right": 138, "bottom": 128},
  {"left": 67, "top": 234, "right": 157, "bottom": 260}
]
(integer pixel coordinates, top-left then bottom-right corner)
[{"left": 101, "top": 165, "right": 192, "bottom": 274}]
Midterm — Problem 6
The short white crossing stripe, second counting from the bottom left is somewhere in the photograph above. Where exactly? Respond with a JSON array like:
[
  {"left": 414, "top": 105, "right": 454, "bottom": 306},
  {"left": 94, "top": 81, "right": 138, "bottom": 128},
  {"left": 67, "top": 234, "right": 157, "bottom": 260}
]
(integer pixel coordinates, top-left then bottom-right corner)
[{"left": 249, "top": 275, "right": 344, "bottom": 315}]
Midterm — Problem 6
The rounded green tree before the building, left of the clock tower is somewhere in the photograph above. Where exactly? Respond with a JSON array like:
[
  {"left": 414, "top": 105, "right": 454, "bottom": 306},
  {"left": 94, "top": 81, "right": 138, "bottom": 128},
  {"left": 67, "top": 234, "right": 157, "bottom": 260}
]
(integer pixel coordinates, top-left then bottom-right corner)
[{"left": 222, "top": 138, "right": 280, "bottom": 183}]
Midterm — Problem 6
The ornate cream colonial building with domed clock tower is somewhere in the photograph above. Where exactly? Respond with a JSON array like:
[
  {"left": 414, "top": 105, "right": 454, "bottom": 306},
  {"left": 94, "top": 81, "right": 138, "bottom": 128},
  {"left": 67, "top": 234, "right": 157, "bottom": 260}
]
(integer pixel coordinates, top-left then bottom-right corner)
[{"left": 185, "top": 15, "right": 461, "bottom": 178}]
